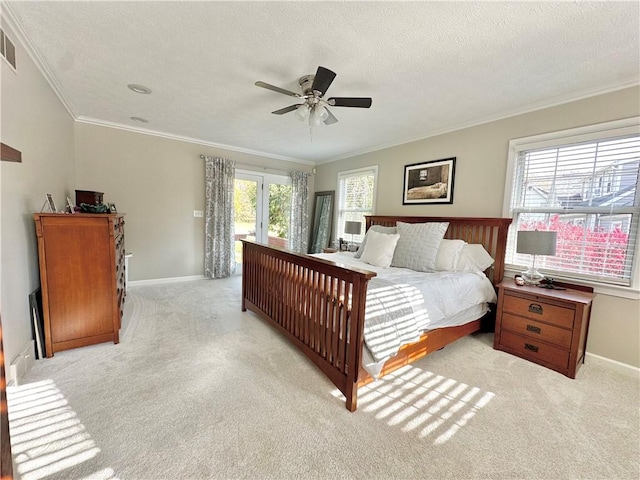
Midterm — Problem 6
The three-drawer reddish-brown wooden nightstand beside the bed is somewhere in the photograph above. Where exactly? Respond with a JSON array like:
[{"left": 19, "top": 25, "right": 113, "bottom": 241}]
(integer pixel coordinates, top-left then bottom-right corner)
[{"left": 493, "top": 280, "right": 594, "bottom": 378}]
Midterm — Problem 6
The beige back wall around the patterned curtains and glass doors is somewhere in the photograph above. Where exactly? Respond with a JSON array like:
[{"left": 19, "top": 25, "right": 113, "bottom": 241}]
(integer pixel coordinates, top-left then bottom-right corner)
[{"left": 75, "top": 123, "right": 311, "bottom": 281}]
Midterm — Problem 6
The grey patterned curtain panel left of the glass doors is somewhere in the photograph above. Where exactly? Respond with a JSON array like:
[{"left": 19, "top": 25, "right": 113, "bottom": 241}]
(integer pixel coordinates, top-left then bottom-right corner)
[{"left": 204, "top": 156, "right": 236, "bottom": 278}]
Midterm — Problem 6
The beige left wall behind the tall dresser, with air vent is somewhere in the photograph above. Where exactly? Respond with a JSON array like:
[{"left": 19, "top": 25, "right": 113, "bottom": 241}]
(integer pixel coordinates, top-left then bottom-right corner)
[{"left": 0, "top": 19, "right": 74, "bottom": 364}]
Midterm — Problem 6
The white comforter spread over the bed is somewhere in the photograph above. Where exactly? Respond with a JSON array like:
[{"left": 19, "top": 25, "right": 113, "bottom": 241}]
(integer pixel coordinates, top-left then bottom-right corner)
[{"left": 315, "top": 252, "right": 496, "bottom": 377}]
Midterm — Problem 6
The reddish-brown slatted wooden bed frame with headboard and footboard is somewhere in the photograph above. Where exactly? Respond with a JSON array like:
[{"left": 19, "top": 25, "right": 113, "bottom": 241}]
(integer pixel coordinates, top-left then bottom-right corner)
[{"left": 242, "top": 216, "right": 511, "bottom": 412}]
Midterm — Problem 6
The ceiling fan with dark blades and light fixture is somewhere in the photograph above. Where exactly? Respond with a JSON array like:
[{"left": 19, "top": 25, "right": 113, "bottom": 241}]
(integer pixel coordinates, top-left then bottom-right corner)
[{"left": 255, "top": 67, "right": 371, "bottom": 126}]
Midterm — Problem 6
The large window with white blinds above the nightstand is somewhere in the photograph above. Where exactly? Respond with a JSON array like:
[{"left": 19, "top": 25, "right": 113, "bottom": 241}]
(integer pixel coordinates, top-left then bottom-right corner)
[{"left": 505, "top": 118, "right": 640, "bottom": 289}]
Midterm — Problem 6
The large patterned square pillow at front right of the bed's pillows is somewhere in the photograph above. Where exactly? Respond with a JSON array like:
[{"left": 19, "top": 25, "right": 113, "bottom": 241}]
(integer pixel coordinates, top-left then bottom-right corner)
[{"left": 391, "top": 222, "right": 449, "bottom": 272}]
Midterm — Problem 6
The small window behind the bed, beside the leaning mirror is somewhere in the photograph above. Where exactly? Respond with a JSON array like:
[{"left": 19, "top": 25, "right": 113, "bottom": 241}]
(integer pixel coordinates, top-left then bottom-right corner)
[{"left": 336, "top": 165, "right": 378, "bottom": 243}]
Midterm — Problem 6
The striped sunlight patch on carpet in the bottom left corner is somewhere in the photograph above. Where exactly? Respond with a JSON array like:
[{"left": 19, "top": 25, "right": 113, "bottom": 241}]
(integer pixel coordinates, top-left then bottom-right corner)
[{"left": 7, "top": 380, "right": 116, "bottom": 480}]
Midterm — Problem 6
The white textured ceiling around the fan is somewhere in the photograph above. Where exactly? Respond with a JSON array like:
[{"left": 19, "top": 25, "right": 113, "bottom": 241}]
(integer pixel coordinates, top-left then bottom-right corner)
[{"left": 6, "top": 1, "right": 640, "bottom": 163}]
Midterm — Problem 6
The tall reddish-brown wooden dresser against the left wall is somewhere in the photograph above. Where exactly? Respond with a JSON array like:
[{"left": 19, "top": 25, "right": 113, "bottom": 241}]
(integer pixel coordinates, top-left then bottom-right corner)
[{"left": 33, "top": 213, "right": 126, "bottom": 357}]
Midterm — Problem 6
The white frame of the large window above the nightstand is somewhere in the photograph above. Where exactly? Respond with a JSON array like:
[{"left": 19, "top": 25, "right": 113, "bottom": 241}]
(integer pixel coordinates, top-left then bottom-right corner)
[{"left": 502, "top": 116, "right": 640, "bottom": 300}]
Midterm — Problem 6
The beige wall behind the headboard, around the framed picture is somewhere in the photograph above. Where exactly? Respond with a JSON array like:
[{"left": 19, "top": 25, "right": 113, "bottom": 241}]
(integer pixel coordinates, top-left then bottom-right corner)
[{"left": 316, "top": 87, "right": 640, "bottom": 367}]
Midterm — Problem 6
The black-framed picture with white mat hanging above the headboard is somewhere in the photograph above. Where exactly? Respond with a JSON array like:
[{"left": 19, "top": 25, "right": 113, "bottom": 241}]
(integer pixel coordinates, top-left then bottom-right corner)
[{"left": 402, "top": 157, "right": 456, "bottom": 205}]
